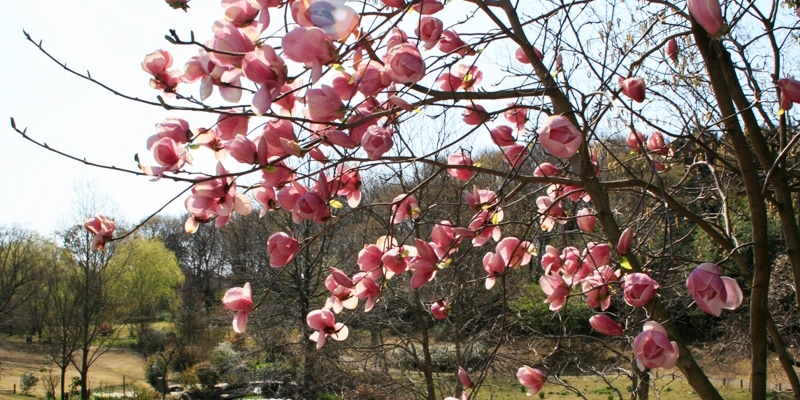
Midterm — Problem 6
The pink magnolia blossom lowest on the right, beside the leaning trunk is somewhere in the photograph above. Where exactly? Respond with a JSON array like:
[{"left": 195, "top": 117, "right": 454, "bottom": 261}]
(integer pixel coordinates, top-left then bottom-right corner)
[{"left": 633, "top": 321, "right": 678, "bottom": 371}]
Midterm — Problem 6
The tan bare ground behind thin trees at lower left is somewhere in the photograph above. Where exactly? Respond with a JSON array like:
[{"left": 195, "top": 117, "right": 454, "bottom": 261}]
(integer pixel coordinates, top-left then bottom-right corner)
[{"left": 0, "top": 339, "right": 144, "bottom": 397}]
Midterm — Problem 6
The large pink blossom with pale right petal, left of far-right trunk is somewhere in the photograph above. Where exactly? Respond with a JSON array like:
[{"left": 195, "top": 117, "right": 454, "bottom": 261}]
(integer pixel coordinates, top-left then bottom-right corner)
[{"left": 686, "top": 263, "right": 744, "bottom": 317}]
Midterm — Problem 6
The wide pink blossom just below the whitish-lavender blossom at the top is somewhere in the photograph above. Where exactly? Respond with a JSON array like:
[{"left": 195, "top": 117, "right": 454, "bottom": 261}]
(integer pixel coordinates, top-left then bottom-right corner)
[{"left": 281, "top": 26, "right": 338, "bottom": 83}]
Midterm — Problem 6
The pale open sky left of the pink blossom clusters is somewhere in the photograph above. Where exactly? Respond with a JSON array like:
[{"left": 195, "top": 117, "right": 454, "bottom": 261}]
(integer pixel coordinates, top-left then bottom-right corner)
[{"left": 0, "top": 0, "right": 222, "bottom": 234}]
